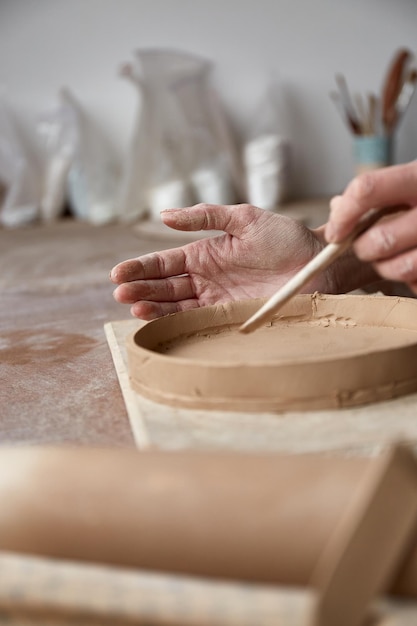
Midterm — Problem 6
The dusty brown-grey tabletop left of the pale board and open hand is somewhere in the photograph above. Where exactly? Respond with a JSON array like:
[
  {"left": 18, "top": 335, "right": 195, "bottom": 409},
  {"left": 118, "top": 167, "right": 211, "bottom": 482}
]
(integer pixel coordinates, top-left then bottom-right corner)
[{"left": 0, "top": 220, "right": 197, "bottom": 446}]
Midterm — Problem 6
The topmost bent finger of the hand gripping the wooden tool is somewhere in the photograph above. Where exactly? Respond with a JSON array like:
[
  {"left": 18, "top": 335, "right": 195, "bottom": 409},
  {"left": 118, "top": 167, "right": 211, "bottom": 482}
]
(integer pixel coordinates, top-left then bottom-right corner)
[{"left": 325, "top": 161, "right": 417, "bottom": 242}]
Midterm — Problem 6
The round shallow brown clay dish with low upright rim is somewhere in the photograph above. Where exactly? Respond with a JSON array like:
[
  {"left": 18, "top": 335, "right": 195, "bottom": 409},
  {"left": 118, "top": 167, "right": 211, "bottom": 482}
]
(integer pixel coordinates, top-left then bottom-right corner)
[{"left": 127, "top": 294, "right": 417, "bottom": 412}]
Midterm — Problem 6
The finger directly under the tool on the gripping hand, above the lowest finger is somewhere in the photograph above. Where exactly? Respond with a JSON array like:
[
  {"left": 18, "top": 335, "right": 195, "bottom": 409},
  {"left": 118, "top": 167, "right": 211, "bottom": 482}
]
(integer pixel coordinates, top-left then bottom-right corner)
[{"left": 354, "top": 207, "right": 417, "bottom": 262}]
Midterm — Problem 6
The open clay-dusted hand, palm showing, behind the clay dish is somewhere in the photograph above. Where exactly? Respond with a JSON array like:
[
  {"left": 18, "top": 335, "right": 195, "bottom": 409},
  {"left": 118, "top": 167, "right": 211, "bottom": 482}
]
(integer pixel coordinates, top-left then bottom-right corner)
[{"left": 110, "top": 204, "right": 335, "bottom": 320}]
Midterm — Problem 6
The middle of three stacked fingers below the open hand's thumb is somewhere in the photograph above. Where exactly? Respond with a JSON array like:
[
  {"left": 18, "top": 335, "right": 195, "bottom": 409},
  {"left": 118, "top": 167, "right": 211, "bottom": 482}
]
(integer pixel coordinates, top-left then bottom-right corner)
[{"left": 113, "top": 276, "right": 194, "bottom": 304}]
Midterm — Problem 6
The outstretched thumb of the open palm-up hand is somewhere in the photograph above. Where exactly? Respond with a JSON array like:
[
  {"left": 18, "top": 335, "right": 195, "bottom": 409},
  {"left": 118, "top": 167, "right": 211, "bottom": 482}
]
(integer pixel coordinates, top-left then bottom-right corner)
[{"left": 161, "top": 204, "right": 255, "bottom": 237}]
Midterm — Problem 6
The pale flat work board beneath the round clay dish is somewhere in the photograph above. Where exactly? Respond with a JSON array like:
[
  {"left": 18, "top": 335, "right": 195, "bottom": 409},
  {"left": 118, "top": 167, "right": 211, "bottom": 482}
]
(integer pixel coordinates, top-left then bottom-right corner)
[{"left": 104, "top": 319, "right": 417, "bottom": 456}]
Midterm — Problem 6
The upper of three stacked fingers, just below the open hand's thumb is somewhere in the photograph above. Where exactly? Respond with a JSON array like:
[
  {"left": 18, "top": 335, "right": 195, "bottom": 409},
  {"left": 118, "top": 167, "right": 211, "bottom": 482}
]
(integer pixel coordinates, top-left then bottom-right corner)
[{"left": 110, "top": 246, "right": 187, "bottom": 285}]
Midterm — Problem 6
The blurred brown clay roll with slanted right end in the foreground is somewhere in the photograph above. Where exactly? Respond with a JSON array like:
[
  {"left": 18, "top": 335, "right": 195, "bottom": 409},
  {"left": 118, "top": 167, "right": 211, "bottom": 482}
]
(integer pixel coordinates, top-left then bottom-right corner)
[{"left": 0, "top": 438, "right": 417, "bottom": 600}]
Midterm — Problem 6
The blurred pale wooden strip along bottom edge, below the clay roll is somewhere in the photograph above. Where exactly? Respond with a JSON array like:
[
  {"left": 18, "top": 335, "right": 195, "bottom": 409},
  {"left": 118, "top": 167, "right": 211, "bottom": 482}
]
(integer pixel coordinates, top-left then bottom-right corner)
[{"left": 0, "top": 553, "right": 416, "bottom": 626}]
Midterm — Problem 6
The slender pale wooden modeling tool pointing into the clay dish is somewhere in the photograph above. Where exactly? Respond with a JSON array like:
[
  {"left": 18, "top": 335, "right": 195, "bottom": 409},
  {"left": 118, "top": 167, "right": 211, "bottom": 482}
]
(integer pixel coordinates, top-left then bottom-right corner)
[{"left": 239, "top": 207, "right": 398, "bottom": 334}]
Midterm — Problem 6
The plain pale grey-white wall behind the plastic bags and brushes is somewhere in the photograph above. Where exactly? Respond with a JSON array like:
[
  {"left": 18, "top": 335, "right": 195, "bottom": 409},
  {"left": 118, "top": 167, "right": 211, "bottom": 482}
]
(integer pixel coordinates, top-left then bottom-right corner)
[{"left": 0, "top": 0, "right": 417, "bottom": 197}]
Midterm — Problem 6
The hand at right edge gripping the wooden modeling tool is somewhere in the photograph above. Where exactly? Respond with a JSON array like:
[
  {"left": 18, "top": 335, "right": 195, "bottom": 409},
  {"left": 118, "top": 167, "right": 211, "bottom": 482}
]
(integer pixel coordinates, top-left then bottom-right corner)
[{"left": 325, "top": 161, "right": 417, "bottom": 293}]
